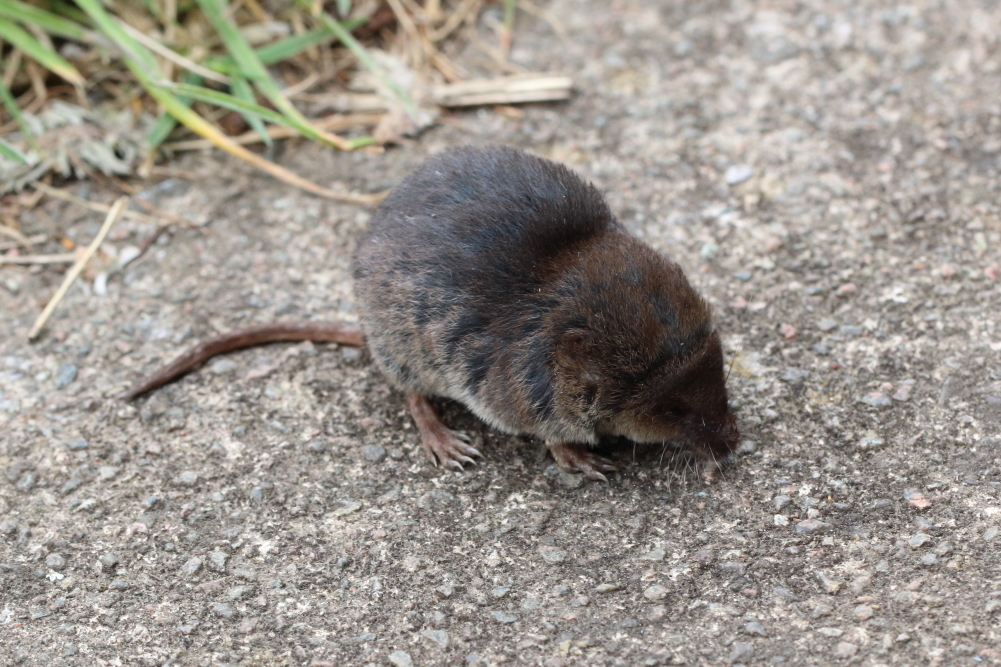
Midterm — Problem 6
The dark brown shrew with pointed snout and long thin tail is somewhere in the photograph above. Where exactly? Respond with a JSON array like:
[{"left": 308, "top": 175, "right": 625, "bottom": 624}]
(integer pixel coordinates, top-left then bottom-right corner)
[{"left": 128, "top": 146, "right": 739, "bottom": 480}]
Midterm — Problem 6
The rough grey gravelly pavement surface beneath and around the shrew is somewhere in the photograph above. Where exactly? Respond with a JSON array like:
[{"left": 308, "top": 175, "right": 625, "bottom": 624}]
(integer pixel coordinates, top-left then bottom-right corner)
[{"left": 0, "top": 0, "right": 1001, "bottom": 667}]
